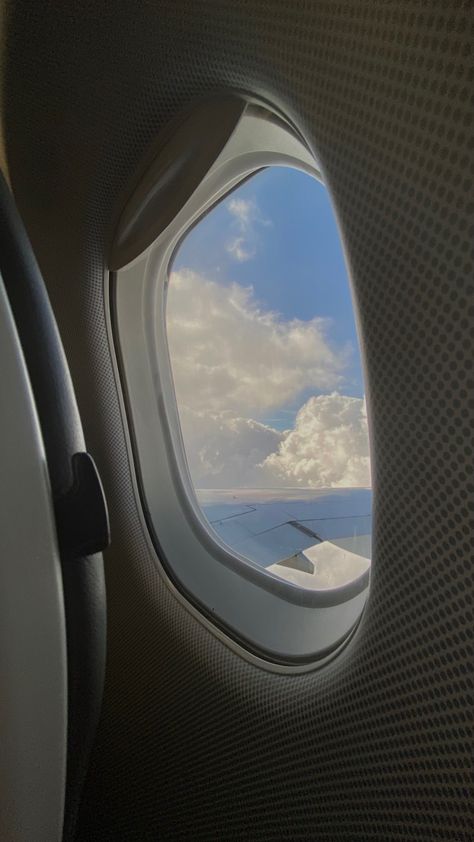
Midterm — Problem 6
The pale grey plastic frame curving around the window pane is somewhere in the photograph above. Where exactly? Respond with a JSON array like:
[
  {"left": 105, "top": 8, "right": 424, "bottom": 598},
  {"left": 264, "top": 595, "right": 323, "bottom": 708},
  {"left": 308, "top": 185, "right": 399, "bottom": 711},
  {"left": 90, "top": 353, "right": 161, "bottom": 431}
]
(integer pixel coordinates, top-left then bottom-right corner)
[{"left": 108, "top": 97, "right": 370, "bottom": 665}]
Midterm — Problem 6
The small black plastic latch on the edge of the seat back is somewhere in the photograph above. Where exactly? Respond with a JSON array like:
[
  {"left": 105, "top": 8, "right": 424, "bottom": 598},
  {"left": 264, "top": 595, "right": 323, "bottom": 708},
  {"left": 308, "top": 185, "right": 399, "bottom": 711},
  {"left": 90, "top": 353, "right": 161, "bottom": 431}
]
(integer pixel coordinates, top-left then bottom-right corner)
[{"left": 54, "top": 453, "right": 110, "bottom": 560}]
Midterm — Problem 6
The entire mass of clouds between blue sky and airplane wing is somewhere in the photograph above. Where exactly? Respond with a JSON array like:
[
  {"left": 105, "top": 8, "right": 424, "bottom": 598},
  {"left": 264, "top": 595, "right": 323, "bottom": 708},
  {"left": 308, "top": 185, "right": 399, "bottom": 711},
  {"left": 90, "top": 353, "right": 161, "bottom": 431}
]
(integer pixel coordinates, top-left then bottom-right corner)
[{"left": 167, "top": 270, "right": 370, "bottom": 488}]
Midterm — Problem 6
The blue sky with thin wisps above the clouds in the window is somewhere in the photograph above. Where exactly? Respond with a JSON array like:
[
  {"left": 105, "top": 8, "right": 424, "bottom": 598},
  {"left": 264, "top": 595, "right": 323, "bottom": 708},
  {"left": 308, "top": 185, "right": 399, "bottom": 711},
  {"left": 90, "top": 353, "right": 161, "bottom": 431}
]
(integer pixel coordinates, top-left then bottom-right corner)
[{"left": 173, "top": 167, "right": 364, "bottom": 429}]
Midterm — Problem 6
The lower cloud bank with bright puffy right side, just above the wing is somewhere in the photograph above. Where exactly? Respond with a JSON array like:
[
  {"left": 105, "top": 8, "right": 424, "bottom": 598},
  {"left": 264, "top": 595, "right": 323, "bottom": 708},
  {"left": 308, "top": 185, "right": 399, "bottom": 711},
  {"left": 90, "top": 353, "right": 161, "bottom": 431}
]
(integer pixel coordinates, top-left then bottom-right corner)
[{"left": 181, "top": 394, "right": 370, "bottom": 488}]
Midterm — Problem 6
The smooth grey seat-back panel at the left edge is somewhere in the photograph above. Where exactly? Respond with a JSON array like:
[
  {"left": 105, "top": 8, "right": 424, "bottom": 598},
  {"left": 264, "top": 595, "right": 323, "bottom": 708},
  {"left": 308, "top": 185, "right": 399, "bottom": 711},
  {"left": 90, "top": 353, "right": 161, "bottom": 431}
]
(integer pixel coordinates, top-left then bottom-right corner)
[{"left": 0, "top": 278, "right": 67, "bottom": 842}]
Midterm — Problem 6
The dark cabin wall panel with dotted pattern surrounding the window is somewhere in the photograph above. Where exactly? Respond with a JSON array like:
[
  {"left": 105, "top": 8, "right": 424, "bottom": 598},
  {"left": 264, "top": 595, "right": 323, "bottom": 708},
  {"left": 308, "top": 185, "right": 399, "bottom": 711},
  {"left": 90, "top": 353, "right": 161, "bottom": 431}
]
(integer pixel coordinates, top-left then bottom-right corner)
[{"left": 3, "top": 0, "right": 474, "bottom": 842}]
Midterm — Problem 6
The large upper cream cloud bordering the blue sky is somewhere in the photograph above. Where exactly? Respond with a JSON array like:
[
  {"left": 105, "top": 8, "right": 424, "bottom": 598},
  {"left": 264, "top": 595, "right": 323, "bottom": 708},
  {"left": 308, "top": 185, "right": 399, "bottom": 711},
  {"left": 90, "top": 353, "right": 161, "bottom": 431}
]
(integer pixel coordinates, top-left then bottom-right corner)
[{"left": 167, "top": 270, "right": 350, "bottom": 419}]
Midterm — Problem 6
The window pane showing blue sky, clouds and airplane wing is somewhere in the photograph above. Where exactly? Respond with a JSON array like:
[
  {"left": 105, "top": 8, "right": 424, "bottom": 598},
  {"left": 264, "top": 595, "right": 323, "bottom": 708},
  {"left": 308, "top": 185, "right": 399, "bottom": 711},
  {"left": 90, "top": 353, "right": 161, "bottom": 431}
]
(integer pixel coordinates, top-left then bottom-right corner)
[{"left": 166, "top": 166, "right": 372, "bottom": 590}]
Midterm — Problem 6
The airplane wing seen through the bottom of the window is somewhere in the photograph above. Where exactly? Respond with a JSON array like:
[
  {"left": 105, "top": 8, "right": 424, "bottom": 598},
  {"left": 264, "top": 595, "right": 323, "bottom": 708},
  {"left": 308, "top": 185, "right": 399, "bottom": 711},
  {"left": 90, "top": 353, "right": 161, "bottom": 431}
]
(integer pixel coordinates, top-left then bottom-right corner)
[{"left": 197, "top": 488, "right": 372, "bottom": 590}]
